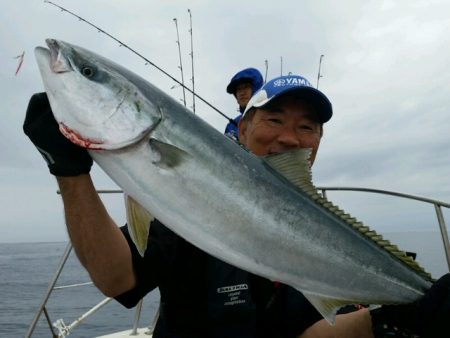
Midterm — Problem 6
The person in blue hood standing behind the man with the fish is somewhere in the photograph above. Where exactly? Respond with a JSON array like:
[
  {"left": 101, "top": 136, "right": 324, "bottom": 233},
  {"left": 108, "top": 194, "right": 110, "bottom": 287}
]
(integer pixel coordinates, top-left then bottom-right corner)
[{"left": 225, "top": 68, "right": 264, "bottom": 140}]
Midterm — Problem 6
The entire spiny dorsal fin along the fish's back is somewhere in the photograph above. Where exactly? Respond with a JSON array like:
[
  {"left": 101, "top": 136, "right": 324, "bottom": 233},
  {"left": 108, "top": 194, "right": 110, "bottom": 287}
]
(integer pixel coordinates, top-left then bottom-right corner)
[{"left": 264, "top": 149, "right": 432, "bottom": 280}]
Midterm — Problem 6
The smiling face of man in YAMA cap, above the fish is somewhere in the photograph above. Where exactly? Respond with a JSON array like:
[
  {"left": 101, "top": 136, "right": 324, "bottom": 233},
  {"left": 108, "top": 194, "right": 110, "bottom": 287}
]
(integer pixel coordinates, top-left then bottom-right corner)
[{"left": 239, "top": 96, "right": 322, "bottom": 165}]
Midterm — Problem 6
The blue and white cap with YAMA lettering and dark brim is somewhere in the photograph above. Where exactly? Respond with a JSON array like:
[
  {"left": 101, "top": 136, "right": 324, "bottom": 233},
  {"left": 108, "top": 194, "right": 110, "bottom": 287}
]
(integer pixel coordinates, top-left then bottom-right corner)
[{"left": 242, "top": 75, "right": 333, "bottom": 123}]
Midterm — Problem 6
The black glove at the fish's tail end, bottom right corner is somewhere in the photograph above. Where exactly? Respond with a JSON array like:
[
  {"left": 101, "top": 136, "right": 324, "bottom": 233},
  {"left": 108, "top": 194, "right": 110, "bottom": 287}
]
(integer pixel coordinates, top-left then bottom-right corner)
[{"left": 371, "top": 274, "right": 450, "bottom": 338}]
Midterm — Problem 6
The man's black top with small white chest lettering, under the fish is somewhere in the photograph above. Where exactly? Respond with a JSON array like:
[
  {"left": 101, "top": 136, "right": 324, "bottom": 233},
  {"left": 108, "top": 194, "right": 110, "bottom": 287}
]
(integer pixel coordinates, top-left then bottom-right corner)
[{"left": 116, "top": 220, "right": 321, "bottom": 338}]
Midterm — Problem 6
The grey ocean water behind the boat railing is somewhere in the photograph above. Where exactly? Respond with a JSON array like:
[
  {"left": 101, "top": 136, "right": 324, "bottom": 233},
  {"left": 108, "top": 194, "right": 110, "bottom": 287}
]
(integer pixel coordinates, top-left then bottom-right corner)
[{"left": 0, "top": 232, "right": 448, "bottom": 338}]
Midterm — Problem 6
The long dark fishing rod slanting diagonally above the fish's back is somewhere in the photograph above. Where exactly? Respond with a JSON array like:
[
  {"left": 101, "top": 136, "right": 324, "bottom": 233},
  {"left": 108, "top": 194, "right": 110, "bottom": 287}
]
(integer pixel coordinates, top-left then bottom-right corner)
[{"left": 44, "top": 0, "right": 236, "bottom": 125}]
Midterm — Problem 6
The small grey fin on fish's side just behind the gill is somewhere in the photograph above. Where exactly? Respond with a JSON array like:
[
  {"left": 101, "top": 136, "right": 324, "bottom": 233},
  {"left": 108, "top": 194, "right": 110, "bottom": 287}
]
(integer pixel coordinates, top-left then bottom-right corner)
[{"left": 148, "top": 138, "right": 188, "bottom": 169}]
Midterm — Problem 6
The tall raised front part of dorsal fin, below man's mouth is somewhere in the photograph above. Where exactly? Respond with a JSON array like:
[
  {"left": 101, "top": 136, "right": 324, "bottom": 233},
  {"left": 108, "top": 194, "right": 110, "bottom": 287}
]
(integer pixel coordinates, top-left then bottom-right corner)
[{"left": 264, "top": 149, "right": 315, "bottom": 190}]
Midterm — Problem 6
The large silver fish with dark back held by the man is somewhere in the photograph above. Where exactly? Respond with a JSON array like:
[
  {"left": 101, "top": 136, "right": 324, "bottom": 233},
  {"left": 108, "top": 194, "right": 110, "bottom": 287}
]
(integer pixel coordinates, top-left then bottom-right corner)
[{"left": 35, "top": 39, "right": 431, "bottom": 322}]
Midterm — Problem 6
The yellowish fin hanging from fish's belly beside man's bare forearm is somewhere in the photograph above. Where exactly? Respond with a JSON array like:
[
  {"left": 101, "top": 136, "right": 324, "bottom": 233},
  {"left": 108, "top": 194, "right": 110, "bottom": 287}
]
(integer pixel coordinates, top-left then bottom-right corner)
[{"left": 125, "top": 195, "right": 154, "bottom": 257}]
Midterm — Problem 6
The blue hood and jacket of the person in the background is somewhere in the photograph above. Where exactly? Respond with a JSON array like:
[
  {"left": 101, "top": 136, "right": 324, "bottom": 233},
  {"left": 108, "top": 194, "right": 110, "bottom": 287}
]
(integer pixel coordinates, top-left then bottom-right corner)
[{"left": 225, "top": 68, "right": 264, "bottom": 140}]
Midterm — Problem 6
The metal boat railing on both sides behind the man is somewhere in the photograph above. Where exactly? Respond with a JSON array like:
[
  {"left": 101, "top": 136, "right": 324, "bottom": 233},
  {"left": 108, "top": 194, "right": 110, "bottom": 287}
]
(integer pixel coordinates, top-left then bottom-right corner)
[{"left": 25, "top": 187, "right": 450, "bottom": 338}]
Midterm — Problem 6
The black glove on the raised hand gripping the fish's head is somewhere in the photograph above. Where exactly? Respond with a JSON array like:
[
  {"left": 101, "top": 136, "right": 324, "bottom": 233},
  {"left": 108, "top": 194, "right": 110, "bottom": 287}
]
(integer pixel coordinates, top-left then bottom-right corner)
[{"left": 23, "top": 93, "right": 92, "bottom": 176}]
